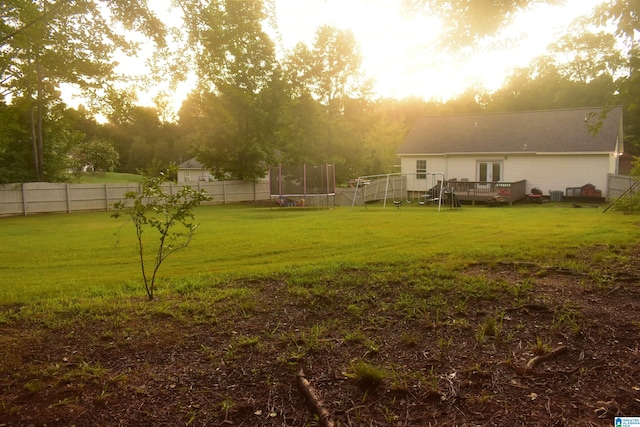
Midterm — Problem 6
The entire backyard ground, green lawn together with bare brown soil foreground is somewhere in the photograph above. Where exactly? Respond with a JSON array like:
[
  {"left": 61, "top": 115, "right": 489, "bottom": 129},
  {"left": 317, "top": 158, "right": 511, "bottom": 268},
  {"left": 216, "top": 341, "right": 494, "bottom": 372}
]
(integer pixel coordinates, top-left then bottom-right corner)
[{"left": 0, "top": 204, "right": 640, "bottom": 426}]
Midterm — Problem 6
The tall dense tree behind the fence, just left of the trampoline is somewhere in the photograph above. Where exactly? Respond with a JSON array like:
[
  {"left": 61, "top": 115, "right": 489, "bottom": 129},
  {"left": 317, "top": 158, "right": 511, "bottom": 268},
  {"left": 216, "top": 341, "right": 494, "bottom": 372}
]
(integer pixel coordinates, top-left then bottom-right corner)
[{"left": 177, "top": 0, "right": 284, "bottom": 179}]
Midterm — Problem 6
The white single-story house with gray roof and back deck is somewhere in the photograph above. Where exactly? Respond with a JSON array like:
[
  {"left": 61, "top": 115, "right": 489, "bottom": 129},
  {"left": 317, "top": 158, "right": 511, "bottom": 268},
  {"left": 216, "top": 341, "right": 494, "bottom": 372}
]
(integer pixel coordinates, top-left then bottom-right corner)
[{"left": 397, "top": 107, "right": 624, "bottom": 201}]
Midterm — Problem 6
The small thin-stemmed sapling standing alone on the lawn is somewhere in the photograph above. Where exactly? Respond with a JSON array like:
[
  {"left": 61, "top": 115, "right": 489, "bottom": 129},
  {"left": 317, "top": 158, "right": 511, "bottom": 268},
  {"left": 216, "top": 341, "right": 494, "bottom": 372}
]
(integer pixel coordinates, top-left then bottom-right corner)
[{"left": 111, "top": 174, "right": 211, "bottom": 300}]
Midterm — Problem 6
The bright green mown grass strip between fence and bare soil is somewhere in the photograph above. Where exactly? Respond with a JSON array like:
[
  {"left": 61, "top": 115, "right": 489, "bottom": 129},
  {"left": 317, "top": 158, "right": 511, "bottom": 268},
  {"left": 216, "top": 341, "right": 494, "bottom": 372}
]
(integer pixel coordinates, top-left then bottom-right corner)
[{"left": 0, "top": 204, "right": 640, "bottom": 304}]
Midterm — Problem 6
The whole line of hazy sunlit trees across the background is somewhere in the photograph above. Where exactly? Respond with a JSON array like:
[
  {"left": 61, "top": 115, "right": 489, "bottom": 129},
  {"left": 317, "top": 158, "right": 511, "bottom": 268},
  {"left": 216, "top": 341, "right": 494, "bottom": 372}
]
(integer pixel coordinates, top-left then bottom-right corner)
[{"left": 0, "top": 0, "right": 640, "bottom": 183}]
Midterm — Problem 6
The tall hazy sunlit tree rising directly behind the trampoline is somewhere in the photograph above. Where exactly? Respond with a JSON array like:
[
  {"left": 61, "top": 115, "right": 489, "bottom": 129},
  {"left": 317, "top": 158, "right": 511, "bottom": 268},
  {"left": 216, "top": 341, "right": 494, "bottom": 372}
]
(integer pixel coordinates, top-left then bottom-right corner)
[{"left": 284, "top": 26, "right": 371, "bottom": 179}]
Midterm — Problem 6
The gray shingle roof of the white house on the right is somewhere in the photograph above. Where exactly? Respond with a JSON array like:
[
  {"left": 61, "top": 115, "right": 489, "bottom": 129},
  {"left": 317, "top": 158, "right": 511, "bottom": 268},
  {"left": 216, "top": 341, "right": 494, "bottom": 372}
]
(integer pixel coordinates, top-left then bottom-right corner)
[{"left": 397, "top": 107, "right": 622, "bottom": 155}]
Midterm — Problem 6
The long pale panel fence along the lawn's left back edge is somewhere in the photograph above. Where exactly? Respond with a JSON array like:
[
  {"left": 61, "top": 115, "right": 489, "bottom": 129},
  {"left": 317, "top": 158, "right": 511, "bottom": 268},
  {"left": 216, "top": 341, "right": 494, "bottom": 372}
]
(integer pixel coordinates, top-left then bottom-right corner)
[{"left": 0, "top": 181, "right": 270, "bottom": 216}]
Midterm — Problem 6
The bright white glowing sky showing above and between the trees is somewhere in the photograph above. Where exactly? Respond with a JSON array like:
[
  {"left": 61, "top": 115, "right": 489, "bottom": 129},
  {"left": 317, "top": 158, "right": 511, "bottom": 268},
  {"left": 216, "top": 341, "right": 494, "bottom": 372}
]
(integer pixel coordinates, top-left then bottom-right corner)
[{"left": 65, "top": 0, "right": 603, "bottom": 110}]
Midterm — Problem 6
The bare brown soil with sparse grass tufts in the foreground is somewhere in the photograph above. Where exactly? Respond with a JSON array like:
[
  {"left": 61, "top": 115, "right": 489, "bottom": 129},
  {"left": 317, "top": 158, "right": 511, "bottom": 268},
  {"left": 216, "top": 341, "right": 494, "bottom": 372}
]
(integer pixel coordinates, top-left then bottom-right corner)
[{"left": 0, "top": 247, "right": 640, "bottom": 426}]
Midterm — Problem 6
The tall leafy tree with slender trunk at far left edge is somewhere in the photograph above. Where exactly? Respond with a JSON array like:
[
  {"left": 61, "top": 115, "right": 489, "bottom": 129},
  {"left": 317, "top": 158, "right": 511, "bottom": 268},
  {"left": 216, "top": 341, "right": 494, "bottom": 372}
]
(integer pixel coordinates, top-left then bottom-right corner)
[{"left": 0, "top": 0, "right": 163, "bottom": 180}]
